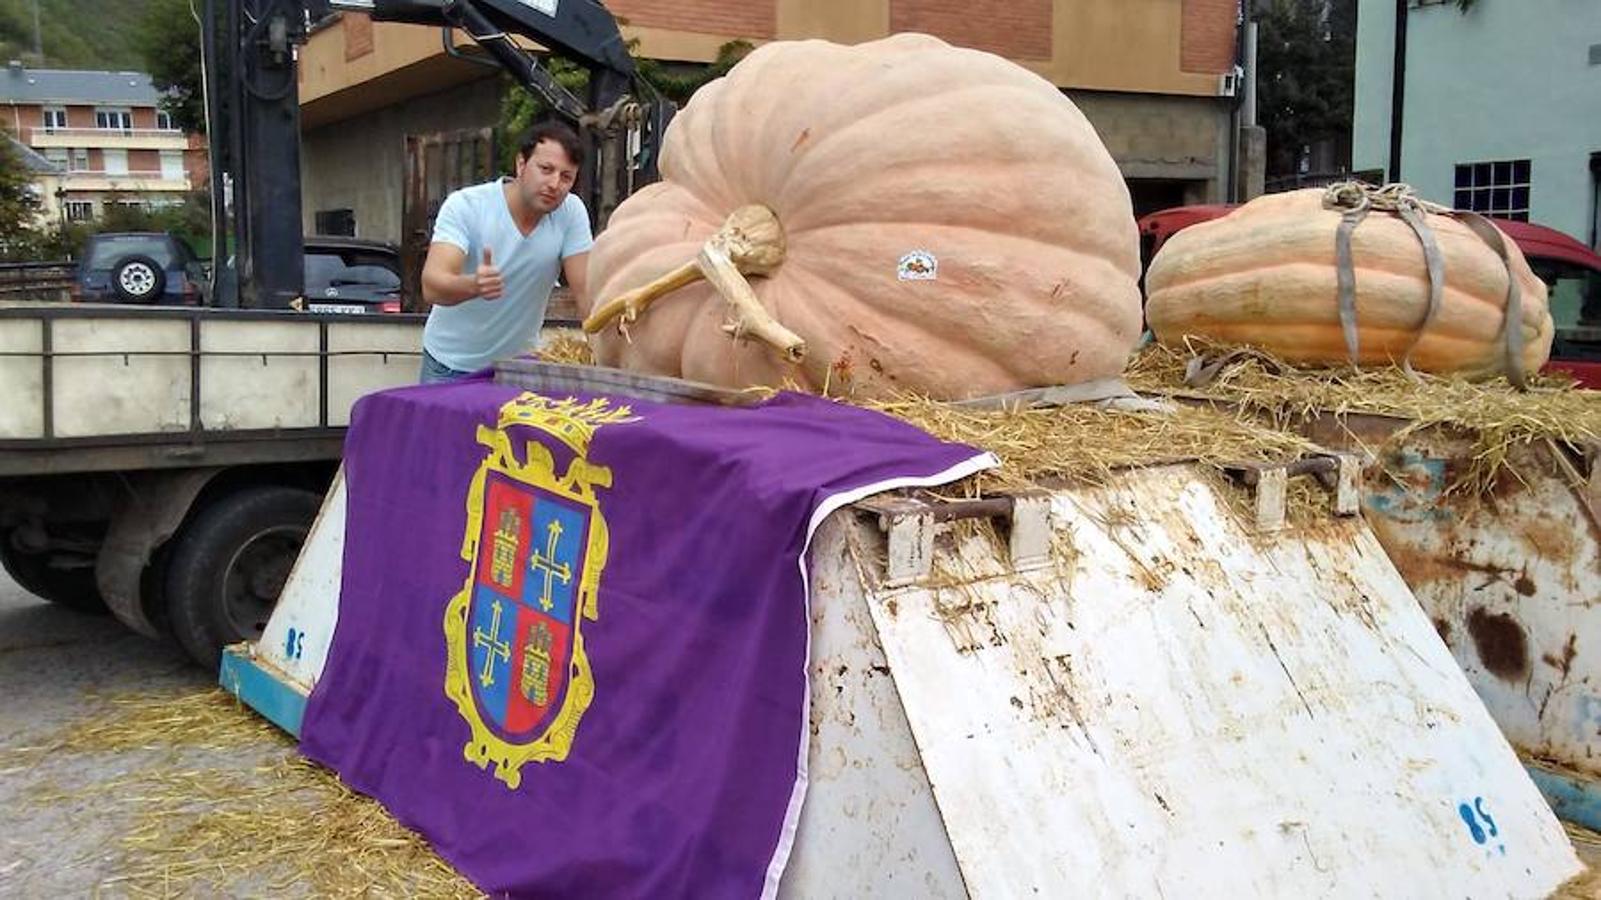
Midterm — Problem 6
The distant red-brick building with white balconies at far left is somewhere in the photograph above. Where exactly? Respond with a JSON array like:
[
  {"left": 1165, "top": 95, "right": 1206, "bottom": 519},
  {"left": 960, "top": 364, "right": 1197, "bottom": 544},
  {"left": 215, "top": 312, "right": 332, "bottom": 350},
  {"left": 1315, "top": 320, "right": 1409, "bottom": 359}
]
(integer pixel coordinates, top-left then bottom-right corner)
[{"left": 0, "top": 62, "right": 210, "bottom": 221}]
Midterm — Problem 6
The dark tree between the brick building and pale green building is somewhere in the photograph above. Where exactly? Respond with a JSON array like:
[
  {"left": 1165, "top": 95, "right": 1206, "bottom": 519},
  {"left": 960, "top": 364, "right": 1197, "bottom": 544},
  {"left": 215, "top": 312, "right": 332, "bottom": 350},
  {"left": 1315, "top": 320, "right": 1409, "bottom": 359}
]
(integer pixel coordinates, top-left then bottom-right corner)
[{"left": 1257, "top": 0, "right": 1356, "bottom": 178}]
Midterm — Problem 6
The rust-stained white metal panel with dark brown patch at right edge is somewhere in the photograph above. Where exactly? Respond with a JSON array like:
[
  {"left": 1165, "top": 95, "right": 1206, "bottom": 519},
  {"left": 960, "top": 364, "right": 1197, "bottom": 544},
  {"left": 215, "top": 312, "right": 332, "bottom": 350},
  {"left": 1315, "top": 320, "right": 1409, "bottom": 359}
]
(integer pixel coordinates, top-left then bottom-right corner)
[{"left": 1366, "top": 432, "right": 1601, "bottom": 778}]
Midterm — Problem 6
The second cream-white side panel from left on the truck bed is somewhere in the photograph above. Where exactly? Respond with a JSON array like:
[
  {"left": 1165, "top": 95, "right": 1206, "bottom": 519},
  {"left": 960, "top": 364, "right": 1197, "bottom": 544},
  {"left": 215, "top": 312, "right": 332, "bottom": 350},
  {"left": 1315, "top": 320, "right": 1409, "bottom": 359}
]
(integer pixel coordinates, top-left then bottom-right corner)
[{"left": 51, "top": 314, "right": 191, "bottom": 437}]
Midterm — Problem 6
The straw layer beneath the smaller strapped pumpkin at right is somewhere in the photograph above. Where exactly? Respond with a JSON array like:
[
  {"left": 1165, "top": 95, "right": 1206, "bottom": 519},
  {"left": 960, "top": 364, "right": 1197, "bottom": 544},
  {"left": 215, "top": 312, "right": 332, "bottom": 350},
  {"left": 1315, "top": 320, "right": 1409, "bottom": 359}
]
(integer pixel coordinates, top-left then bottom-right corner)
[{"left": 1127, "top": 340, "right": 1601, "bottom": 492}]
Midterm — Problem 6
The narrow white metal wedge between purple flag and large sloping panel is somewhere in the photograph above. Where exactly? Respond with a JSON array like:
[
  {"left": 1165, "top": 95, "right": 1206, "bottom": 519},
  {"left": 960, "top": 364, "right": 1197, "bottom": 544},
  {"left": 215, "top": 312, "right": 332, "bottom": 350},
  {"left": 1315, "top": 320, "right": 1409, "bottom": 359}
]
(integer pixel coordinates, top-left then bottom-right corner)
[{"left": 780, "top": 509, "right": 965, "bottom": 900}]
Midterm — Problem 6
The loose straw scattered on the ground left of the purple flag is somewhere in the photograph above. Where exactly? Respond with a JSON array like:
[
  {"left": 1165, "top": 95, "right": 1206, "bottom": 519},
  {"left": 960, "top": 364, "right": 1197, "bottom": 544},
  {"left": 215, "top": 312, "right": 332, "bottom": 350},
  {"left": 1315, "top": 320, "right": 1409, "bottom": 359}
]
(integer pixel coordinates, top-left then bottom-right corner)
[{"left": 17, "top": 689, "right": 482, "bottom": 897}]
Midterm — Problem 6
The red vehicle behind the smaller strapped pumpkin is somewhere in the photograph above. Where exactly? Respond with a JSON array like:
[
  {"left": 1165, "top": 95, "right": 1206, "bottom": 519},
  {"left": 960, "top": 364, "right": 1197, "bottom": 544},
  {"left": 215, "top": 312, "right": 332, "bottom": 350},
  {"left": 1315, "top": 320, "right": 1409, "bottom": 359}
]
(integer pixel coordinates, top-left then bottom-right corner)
[{"left": 1140, "top": 203, "right": 1601, "bottom": 389}]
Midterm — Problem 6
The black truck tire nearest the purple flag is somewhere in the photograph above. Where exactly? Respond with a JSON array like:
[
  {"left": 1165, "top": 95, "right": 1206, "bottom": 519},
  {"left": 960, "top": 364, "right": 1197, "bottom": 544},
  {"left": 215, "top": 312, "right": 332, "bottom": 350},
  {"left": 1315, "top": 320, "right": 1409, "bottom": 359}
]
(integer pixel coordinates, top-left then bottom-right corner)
[{"left": 167, "top": 487, "right": 322, "bottom": 669}]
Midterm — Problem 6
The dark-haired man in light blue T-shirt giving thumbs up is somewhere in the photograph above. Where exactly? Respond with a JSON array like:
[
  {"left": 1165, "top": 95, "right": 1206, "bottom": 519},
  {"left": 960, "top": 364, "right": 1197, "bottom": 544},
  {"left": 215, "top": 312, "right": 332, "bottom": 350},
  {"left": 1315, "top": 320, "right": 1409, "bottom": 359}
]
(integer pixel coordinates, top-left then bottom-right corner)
[{"left": 423, "top": 122, "right": 594, "bottom": 383}]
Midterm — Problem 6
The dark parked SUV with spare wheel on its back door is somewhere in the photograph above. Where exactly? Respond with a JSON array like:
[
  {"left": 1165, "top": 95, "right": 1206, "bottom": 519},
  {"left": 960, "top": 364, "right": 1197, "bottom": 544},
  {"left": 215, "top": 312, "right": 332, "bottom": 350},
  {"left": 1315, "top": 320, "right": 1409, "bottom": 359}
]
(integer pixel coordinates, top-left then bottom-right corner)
[{"left": 72, "top": 232, "right": 205, "bottom": 306}]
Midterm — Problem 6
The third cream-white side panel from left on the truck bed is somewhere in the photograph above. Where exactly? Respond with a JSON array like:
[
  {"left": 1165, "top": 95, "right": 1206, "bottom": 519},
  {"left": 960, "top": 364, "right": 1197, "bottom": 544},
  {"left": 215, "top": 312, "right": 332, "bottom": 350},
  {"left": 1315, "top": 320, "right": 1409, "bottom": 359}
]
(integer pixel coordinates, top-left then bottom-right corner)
[{"left": 200, "top": 314, "right": 320, "bottom": 431}]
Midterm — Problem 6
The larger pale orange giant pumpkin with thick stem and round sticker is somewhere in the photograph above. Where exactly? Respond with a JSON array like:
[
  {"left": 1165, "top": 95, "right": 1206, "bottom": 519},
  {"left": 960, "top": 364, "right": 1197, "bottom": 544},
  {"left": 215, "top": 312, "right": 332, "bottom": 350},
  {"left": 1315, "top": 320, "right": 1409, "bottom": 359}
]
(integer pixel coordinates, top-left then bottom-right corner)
[{"left": 583, "top": 34, "right": 1140, "bottom": 397}]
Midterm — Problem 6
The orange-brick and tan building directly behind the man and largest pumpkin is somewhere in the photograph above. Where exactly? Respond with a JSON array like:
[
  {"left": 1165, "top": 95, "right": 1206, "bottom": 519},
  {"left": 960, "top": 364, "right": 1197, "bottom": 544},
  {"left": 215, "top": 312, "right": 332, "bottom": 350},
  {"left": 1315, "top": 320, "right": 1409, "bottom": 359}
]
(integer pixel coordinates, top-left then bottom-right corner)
[{"left": 301, "top": 0, "right": 1238, "bottom": 242}]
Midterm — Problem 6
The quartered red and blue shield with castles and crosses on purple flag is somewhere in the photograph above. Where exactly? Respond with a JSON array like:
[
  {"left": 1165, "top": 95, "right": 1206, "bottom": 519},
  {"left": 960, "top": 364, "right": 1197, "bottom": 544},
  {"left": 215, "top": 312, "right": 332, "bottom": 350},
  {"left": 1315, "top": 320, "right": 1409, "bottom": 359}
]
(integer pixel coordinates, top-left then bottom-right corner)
[{"left": 463, "top": 471, "right": 591, "bottom": 743}]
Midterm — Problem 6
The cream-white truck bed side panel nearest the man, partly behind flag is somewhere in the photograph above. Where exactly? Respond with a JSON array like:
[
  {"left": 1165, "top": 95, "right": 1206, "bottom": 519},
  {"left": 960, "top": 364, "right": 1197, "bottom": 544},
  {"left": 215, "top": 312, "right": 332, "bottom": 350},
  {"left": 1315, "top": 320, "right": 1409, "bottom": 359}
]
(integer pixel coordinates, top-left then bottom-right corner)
[{"left": 328, "top": 315, "right": 423, "bottom": 424}]
